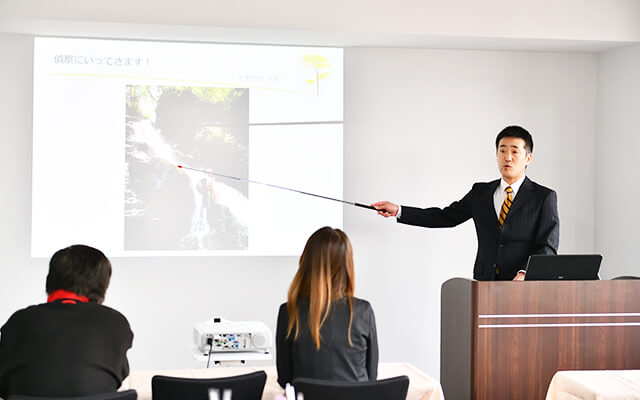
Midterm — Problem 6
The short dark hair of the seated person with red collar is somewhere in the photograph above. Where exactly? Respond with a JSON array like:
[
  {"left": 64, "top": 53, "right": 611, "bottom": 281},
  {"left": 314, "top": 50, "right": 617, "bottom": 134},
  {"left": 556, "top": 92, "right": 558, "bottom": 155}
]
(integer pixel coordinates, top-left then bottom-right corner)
[{"left": 47, "top": 244, "right": 111, "bottom": 303}]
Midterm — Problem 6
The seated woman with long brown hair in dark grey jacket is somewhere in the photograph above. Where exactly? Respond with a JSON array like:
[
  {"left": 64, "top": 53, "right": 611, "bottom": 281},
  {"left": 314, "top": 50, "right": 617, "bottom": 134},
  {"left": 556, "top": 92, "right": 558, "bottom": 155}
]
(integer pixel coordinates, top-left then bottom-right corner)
[{"left": 276, "top": 227, "right": 378, "bottom": 387}]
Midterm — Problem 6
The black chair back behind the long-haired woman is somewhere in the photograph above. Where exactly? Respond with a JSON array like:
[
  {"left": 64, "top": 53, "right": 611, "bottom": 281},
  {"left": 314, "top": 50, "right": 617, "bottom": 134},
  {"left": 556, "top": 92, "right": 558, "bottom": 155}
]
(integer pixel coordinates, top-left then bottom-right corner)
[{"left": 292, "top": 375, "right": 409, "bottom": 400}]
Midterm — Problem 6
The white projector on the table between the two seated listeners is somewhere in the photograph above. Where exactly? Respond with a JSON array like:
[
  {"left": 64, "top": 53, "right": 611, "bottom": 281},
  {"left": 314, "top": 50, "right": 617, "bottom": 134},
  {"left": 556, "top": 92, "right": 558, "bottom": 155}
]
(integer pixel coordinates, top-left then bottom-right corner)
[{"left": 193, "top": 318, "right": 272, "bottom": 354}]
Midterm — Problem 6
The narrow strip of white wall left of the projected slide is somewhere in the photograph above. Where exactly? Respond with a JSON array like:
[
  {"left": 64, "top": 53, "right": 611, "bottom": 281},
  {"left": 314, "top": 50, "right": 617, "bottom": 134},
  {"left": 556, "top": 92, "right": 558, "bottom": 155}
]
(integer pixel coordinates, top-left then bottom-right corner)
[{"left": 0, "top": 35, "right": 44, "bottom": 316}]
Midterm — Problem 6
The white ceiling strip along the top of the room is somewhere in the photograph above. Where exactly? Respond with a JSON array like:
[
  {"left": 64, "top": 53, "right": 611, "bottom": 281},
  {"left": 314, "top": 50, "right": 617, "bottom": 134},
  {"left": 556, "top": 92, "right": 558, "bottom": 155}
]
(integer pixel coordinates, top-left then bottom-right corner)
[{"left": 0, "top": 0, "right": 640, "bottom": 53}]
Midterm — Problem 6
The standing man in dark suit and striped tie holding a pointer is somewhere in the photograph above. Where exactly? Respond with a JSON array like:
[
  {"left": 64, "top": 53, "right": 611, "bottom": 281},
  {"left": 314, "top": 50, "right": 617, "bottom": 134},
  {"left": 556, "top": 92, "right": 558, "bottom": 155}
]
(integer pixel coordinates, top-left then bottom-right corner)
[{"left": 372, "top": 126, "right": 560, "bottom": 281}]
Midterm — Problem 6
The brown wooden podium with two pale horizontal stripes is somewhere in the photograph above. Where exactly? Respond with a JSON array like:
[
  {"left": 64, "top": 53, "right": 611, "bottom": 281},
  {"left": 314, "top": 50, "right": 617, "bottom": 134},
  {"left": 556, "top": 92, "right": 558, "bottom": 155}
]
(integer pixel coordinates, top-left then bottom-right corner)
[{"left": 440, "top": 278, "right": 640, "bottom": 400}]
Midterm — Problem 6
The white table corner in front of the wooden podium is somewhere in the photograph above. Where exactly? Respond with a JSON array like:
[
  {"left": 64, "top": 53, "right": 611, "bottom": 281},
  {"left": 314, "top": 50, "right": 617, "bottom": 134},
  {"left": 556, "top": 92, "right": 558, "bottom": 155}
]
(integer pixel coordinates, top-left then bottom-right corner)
[{"left": 546, "top": 370, "right": 640, "bottom": 400}]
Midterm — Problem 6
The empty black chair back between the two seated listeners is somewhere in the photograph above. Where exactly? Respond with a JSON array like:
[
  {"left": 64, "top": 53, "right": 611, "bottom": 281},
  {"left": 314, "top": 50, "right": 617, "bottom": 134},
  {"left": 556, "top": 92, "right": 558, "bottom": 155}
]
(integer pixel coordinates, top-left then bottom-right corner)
[{"left": 151, "top": 371, "right": 267, "bottom": 400}]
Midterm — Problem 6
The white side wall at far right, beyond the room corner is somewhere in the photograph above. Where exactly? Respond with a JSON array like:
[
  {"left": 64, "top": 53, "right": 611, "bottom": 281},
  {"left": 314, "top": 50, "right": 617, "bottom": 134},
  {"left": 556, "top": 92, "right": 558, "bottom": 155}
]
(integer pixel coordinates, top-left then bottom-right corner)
[{"left": 595, "top": 46, "right": 640, "bottom": 278}]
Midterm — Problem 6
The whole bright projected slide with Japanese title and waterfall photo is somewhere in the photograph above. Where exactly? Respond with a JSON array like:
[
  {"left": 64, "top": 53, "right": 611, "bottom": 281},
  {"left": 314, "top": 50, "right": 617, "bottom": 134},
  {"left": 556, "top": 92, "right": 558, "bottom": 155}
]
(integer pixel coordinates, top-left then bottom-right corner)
[{"left": 31, "top": 37, "right": 343, "bottom": 257}]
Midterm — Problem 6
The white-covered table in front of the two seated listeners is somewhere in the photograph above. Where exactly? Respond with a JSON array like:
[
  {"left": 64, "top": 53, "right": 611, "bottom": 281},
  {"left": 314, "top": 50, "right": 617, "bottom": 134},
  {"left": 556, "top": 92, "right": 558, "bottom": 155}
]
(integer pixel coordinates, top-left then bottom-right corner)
[{"left": 120, "top": 363, "right": 444, "bottom": 400}]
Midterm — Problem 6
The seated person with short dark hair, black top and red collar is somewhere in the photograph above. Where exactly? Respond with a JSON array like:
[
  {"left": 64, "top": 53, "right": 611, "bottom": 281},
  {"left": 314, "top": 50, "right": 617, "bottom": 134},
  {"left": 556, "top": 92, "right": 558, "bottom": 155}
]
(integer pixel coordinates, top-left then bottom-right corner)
[{"left": 0, "top": 245, "right": 133, "bottom": 399}]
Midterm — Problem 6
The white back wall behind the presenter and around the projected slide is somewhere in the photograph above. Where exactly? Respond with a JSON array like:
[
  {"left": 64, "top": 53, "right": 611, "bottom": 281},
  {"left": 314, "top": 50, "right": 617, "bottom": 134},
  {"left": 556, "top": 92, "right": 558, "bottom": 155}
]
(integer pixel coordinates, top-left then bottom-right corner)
[{"left": 0, "top": 34, "right": 597, "bottom": 378}]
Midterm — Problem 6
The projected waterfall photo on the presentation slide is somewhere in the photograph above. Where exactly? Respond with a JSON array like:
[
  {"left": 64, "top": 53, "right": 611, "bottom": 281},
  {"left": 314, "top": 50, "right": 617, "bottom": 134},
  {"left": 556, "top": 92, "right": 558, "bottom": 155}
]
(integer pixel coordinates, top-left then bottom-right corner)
[{"left": 124, "top": 85, "right": 249, "bottom": 250}]
